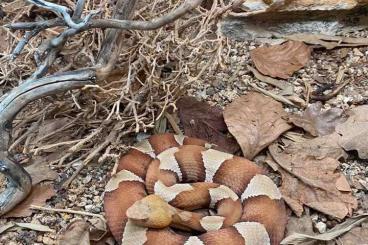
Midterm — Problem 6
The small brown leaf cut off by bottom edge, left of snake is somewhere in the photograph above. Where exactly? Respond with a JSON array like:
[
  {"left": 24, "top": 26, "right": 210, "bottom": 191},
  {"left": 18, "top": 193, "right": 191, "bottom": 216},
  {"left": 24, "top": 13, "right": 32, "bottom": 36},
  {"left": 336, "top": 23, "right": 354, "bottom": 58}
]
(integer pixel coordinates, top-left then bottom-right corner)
[{"left": 57, "top": 219, "right": 90, "bottom": 245}]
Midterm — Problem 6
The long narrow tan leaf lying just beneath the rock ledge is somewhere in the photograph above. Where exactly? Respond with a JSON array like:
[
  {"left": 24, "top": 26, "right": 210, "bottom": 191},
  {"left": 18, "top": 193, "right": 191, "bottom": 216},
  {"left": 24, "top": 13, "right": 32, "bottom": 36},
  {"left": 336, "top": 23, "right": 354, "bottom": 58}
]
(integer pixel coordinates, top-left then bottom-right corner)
[{"left": 284, "top": 33, "right": 368, "bottom": 49}]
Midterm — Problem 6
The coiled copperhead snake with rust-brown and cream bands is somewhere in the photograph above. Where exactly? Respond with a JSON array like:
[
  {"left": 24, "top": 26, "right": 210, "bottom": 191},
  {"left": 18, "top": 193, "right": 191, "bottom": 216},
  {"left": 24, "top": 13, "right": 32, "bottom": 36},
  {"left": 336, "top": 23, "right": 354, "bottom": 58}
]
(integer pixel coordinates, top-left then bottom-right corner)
[{"left": 104, "top": 134, "right": 287, "bottom": 245}]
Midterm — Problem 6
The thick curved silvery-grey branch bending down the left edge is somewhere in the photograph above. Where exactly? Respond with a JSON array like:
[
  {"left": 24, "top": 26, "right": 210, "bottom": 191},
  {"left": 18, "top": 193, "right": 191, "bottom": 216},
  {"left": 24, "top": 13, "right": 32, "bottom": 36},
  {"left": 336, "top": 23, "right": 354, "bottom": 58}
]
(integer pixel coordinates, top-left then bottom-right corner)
[{"left": 0, "top": 69, "right": 95, "bottom": 216}]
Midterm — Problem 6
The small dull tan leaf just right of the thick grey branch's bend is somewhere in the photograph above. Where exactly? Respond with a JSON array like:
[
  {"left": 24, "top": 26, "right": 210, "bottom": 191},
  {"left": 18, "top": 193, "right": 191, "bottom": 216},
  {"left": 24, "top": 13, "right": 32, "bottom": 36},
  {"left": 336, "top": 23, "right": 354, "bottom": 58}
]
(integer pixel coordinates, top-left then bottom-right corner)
[{"left": 25, "top": 156, "right": 58, "bottom": 185}]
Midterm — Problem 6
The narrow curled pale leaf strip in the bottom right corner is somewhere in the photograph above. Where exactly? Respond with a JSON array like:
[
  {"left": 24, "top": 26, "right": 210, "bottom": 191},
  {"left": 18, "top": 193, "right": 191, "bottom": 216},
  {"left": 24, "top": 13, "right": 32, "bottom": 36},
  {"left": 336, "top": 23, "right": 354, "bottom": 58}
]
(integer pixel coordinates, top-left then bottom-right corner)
[{"left": 281, "top": 213, "right": 368, "bottom": 245}]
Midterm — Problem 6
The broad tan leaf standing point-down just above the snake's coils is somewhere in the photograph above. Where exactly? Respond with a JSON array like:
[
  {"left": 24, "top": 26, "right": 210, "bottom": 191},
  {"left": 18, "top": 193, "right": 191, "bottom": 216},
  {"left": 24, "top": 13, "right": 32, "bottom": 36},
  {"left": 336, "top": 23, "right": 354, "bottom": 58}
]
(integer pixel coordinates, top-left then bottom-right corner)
[{"left": 224, "top": 93, "right": 291, "bottom": 159}]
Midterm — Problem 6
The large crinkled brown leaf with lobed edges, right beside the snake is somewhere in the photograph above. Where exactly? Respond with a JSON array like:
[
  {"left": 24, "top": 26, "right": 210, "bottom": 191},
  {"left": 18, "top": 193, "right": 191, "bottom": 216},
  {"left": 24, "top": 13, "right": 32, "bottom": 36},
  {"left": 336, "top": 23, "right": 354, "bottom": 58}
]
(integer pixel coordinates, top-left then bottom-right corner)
[{"left": 269, "top": 144, "right": 358, "bottom": 219}]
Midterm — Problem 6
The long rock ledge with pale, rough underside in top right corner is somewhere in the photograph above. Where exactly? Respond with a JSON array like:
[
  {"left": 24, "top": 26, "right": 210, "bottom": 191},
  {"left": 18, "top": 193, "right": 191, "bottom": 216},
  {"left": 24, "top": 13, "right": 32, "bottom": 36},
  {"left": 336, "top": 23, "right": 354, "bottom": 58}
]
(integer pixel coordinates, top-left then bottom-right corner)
[{"left": 220, "top": 0, "right": 368, "bottom": 40}]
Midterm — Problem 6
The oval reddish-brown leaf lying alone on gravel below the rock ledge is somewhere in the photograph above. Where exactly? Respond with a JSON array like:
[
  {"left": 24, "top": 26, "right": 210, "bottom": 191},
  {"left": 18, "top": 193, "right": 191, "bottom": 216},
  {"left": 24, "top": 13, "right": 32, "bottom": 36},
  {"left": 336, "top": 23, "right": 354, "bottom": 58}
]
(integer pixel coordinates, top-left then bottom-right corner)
[{"left": 250, "top": 41, "right": 311, "bottom": 79}]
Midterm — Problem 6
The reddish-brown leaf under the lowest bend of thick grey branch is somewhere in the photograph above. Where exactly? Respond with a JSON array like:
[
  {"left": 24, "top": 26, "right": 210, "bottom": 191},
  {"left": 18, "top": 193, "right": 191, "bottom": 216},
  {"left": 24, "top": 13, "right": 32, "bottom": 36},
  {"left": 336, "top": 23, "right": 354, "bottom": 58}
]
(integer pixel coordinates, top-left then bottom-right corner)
[{"left": 4, "top": 184, "right": 55, "bottom": 218}]
